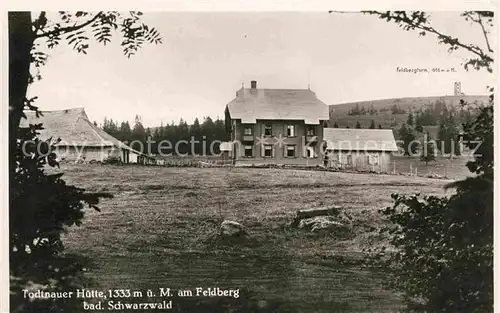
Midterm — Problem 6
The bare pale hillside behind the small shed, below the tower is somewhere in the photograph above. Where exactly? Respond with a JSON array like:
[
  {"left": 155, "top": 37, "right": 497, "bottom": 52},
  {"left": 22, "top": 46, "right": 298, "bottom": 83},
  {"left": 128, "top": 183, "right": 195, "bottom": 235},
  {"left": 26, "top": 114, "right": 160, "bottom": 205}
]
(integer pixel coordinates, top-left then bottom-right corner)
[{"left": 329, "top": 95, "right": 488, "bottom": 129}]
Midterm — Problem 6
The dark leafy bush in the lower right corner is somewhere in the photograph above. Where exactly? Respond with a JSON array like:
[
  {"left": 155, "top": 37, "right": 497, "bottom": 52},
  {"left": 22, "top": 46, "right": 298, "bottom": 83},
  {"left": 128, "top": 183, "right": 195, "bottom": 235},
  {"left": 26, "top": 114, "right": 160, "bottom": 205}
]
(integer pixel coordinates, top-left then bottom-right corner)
[{"left": 375, "top": 98, "right": 494, "bottom": 313}]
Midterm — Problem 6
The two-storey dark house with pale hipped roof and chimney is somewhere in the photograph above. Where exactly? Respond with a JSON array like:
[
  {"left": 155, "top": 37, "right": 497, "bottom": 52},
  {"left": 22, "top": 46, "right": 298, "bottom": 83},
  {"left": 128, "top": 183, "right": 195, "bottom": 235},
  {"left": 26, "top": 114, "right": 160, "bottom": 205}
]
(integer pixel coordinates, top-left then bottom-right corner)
[{"left": 225, "top": 81, "right": 329, "bottom": 166}]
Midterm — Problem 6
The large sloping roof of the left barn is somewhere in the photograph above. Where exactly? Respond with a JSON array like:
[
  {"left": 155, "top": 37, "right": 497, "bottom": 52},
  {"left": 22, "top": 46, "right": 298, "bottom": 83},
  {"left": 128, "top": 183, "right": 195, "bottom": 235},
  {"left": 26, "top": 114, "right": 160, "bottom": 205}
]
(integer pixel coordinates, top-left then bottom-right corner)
[{"left": 21, "top": 108, "right": 140, "bottom": 153}]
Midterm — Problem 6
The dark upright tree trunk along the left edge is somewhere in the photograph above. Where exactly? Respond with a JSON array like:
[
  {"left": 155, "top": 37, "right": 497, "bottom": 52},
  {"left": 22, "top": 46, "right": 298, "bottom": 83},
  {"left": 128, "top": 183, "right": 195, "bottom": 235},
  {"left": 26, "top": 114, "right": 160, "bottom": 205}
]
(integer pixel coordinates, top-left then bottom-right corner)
[{"left": 8, "top": 12, "right": 34, "bottom": 180}]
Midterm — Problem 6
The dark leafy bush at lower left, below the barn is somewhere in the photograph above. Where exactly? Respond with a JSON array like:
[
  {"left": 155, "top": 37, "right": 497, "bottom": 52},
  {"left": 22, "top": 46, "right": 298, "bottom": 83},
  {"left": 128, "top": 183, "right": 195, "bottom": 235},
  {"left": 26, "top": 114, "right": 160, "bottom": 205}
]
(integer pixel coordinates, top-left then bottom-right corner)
[{"left": 9, "top": 120, "right": 111, "bottom": 312}]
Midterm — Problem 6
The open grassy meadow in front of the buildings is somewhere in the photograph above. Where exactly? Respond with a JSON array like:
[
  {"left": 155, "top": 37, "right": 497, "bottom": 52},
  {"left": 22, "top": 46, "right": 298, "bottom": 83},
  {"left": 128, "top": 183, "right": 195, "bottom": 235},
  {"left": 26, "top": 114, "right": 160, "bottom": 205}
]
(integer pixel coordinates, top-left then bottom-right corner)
[{"left": 55, "top": 165, "right": 458, "bottom": 313}]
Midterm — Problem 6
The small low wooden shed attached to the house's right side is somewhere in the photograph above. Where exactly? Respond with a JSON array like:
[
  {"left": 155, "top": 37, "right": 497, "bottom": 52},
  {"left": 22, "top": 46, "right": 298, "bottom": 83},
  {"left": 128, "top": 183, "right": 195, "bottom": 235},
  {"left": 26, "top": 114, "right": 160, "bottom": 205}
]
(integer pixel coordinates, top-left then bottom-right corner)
[{"left": 323, "top": 128, "right": 398, "bottom": 172}]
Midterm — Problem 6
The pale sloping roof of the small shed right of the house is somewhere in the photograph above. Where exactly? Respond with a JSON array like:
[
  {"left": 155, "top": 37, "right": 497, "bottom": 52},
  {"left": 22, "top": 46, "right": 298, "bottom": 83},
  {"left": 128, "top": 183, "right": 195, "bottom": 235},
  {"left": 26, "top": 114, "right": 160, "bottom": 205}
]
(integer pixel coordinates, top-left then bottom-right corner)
[{"left": 323, "top": 128, "right": 398, "bottom": 151}]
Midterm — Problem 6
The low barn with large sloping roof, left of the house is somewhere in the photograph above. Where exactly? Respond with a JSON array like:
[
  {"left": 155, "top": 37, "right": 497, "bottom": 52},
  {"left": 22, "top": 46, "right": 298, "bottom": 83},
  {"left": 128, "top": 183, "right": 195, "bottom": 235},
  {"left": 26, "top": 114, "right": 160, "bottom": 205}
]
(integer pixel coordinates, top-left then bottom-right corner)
[{"left": 21, "top": 108, "right": 151, "bottom": 164}]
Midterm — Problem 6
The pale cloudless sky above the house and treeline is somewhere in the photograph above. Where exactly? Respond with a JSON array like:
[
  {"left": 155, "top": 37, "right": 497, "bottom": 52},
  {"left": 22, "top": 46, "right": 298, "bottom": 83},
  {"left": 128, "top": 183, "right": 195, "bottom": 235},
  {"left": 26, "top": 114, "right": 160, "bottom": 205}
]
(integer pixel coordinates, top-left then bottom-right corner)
[{"left": 29, "top": 12, "right": 496, "bottom": 127}]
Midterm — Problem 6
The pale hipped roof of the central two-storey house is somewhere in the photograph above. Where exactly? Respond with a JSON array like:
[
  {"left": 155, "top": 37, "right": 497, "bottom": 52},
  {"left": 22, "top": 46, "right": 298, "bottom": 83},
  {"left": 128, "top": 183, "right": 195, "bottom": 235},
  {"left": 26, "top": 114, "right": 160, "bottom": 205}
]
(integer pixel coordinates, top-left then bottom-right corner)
[{"left": 227, "top": 88, "right": 329, "bottom": 125}]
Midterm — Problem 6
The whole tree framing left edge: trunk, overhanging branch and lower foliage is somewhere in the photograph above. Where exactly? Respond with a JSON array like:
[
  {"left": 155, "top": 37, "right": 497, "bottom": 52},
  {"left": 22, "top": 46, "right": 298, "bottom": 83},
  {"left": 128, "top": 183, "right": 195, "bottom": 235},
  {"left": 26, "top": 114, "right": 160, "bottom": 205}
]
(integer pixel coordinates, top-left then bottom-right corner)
[{"left": 8, "top": 11, "right": 161, "bottom": 312}]
